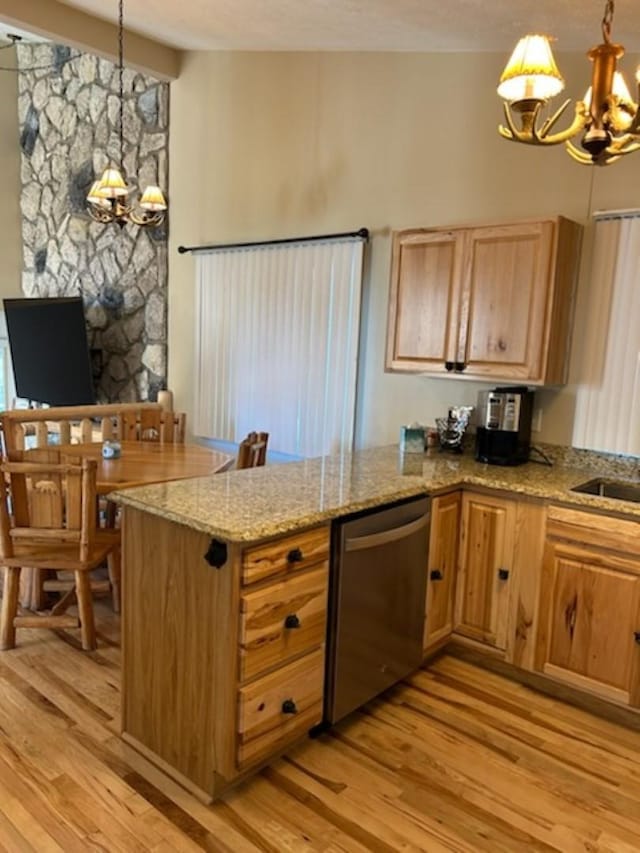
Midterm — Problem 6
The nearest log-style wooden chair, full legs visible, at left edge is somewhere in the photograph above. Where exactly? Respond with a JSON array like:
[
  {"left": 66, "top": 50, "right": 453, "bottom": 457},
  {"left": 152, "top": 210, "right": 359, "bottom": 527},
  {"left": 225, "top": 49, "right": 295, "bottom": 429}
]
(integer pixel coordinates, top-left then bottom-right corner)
[{"left": 0, "top": 450, "right": 120, "bottom": 651}]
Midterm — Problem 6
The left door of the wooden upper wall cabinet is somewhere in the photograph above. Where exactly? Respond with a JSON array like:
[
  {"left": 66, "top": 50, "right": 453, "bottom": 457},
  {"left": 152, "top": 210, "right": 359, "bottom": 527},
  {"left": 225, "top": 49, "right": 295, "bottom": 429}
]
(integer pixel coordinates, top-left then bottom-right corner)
[{"left": 386, "top": 230, "right": 464, "bottom": 373}]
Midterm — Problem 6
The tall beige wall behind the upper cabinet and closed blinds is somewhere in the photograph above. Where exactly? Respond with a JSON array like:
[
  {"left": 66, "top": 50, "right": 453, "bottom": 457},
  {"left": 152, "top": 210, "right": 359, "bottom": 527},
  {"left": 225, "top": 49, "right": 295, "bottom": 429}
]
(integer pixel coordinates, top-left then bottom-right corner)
[{"left": 169, "top": 53, "right": 640, "bottom": 446}]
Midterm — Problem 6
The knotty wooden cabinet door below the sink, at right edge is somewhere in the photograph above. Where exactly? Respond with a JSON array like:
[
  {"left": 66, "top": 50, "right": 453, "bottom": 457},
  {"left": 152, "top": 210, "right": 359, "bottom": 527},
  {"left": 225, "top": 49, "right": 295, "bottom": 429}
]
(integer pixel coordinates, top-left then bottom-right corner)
[{"left": 542, "top": 543, "right": 640, "bottom": 705}]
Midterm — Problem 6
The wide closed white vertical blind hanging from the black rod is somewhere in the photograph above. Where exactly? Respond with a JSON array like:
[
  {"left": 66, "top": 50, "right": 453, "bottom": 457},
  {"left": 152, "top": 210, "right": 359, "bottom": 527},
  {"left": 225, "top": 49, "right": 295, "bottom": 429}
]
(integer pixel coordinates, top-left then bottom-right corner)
[{"left": 194, "top": 233, "right": 364, "bottom": 457}]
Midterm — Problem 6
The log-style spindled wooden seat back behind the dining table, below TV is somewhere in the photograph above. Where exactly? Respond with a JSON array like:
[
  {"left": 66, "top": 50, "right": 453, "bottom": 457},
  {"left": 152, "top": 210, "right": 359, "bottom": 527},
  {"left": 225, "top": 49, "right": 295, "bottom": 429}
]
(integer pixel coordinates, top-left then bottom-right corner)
[{"left": 0, "top": 403, "right": 165, "bottom": 452}]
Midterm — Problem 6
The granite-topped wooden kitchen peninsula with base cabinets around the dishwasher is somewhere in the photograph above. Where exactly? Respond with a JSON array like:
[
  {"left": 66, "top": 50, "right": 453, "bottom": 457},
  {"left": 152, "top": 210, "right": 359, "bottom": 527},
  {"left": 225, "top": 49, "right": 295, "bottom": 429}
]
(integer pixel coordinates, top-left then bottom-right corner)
[{"left": 115, "top": 447, "right": 640, "bottom": 800}]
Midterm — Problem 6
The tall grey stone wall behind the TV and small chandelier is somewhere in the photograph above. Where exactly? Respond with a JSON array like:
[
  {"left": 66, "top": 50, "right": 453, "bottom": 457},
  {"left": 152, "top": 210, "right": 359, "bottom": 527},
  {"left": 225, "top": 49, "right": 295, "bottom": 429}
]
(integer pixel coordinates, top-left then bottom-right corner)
[{"left": 17, "top": 44, "right": 169, "bottom": 402}]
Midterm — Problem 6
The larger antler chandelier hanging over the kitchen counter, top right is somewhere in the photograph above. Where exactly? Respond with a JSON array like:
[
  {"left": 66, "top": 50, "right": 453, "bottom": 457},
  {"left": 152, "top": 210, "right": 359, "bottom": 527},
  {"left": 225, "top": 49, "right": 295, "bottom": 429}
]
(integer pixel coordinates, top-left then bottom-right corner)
[{"left": 498, "top": 0, "right": 640, "bottom": 166}]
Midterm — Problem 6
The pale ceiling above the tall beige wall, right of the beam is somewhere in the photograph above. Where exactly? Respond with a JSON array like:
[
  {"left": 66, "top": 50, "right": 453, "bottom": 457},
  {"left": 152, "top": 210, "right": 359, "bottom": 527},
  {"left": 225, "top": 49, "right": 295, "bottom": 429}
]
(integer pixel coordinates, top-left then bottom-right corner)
[{"left": 52, "top": 0, "right": 640, "bottom": 52}]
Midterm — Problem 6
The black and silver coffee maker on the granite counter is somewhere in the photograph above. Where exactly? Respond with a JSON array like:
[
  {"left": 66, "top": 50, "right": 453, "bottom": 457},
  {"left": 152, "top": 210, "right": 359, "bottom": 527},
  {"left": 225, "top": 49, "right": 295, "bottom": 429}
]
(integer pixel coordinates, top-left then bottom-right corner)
[{"left": 476, "top": 386, "right": 534, "bottom": 465}]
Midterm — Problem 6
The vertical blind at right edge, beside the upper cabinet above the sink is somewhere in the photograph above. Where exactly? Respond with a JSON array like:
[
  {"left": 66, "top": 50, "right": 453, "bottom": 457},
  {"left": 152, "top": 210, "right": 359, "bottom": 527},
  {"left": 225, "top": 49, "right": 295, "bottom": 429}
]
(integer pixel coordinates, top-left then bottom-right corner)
[{"left": 573, "top": 213, "right": 640, "bottom": 455}]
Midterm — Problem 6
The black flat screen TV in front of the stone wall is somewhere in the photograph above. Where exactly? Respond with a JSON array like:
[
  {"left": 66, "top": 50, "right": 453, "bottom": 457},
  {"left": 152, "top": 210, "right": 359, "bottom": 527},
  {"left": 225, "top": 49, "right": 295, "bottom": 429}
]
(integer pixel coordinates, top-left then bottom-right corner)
[{"left": 3, "top": 296, "right": 96, "bottom": 406}]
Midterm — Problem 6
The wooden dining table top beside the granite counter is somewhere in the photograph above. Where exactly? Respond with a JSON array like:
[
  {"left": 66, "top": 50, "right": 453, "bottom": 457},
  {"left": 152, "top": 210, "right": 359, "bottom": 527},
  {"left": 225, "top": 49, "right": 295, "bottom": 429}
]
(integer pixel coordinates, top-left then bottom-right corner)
[{"left": 58, "top": 441, "right": 233, "bottom": 495}]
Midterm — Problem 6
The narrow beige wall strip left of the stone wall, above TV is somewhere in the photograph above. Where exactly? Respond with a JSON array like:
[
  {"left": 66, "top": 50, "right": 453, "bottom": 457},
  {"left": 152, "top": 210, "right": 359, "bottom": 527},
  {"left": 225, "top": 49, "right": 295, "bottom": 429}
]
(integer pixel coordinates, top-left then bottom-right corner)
[{"left": 0, "top": 48, "right": 22, "bottom": 308}]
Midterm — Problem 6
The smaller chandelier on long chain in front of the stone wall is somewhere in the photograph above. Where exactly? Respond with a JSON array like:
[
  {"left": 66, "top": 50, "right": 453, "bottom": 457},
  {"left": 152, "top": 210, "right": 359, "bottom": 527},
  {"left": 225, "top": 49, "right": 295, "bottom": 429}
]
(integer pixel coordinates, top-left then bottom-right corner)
[{"left": 87, "top": 0, "right": 167, "bottom": 228}]
